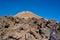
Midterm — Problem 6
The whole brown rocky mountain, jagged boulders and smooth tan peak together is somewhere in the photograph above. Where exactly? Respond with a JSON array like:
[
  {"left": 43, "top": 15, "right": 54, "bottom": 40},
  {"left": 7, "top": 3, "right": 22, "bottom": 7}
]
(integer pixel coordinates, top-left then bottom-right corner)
[{"left": 0, "top": 11, "right": 60, "bottom": 40}]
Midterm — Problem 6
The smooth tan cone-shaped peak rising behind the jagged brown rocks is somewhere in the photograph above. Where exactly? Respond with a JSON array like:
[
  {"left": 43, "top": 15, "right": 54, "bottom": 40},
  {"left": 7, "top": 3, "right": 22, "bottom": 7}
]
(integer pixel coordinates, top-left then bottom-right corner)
[{"left": 14, "top": 11, "right": 42, "bottom": 19}]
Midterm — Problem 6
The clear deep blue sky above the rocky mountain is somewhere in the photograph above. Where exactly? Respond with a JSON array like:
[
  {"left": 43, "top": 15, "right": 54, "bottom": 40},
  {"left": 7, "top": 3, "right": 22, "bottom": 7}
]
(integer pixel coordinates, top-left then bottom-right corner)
[{"left": 0, "top": 0, "right": 60, "bottom": 22}]
